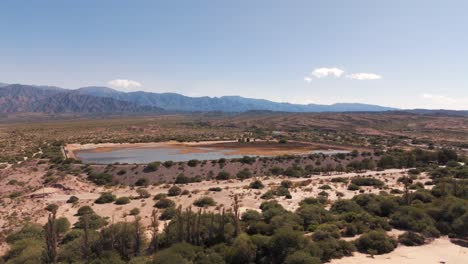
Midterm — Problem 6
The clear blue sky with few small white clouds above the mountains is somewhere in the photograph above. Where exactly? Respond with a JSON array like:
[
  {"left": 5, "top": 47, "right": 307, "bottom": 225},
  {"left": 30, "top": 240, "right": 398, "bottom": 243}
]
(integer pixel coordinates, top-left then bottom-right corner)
[{"left": 0, "top": 0, "right": 468, "bottom": 110}]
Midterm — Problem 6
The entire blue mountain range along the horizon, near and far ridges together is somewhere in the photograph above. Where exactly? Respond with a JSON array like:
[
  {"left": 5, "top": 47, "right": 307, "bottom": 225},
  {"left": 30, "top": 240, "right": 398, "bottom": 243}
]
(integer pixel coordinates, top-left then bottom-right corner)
[{"left": 0, "top": 83, "right": 396, "bottom": 113}]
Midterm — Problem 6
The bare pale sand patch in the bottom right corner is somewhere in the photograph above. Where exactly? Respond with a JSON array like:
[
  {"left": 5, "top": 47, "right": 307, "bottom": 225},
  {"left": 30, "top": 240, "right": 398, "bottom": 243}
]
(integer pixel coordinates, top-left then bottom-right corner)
[{"left": 330, "top": 237, "right": 468, "bottom": 264}]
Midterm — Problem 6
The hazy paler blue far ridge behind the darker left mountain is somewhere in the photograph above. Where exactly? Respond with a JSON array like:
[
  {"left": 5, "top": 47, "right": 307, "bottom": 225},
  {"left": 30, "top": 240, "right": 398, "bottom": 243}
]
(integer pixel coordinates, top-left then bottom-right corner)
[{"left": 76, "top": 87, "right": 396, "bottom": 112}]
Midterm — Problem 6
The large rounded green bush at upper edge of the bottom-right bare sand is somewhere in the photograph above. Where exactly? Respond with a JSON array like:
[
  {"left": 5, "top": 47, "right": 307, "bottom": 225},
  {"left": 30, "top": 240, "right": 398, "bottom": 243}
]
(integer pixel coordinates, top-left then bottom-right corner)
[{"left": 355, "top": 231, "right": 397, "bottom": 255}]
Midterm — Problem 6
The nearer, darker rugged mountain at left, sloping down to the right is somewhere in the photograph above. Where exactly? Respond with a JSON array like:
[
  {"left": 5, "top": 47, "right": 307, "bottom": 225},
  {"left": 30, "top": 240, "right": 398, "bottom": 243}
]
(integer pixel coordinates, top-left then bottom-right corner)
[{"left": 0, "top": 84, "right": 162, "bottom": 114}]
